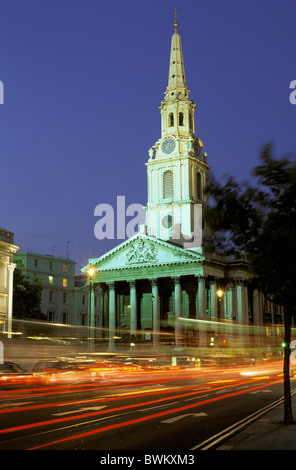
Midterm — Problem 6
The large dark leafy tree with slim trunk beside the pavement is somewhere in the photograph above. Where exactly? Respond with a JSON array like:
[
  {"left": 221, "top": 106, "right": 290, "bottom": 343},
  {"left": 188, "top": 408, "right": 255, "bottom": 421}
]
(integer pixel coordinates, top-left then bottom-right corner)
[{"left": 206, "top": 145, "right": 296, "bottom": 424}]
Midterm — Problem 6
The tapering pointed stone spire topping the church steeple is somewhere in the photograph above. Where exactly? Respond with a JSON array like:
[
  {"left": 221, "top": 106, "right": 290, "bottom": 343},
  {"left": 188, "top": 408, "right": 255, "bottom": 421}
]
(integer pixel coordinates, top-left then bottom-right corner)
[{"left": 165, "top": 9, "right": 188, "bottom": 100}]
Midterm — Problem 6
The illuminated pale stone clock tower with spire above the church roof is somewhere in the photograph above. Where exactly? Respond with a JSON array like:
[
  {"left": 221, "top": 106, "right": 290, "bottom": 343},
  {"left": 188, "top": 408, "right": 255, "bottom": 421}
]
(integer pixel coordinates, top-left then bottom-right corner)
[{"left": 146, "top": 14, "right": 210, "bottom": 249}]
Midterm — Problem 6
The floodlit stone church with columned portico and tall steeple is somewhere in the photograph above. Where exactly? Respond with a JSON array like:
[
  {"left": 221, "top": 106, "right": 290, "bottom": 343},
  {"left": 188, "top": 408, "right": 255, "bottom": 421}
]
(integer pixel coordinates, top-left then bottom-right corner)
[{"left": 82, "top": 18, "right": 281, "bottom": 351}]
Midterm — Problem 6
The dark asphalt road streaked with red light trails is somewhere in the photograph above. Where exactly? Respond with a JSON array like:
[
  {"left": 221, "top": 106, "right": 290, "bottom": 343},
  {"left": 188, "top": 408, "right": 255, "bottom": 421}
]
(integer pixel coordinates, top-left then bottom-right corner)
[{"left": 0, "top": 363, "right": 295, "bottom": 452}]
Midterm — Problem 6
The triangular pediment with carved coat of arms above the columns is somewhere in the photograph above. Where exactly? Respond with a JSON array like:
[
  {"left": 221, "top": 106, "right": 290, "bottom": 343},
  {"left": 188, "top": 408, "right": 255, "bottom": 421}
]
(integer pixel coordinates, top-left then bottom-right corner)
[{"left": 82, "top": 234, "right": 205, "bottom": 271}]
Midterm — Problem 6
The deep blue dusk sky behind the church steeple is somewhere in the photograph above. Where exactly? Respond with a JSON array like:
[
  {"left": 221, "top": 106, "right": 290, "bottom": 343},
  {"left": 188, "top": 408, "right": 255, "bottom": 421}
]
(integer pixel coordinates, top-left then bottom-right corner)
[{"left": 0, "top": 0, "right": 296, "bottom": 269}]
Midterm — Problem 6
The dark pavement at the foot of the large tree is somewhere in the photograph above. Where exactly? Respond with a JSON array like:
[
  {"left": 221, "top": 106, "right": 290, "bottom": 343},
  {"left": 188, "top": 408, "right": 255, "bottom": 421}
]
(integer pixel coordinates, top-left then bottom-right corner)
[{"left": 216, "top": 394, "right": 296, "bottom": 450}]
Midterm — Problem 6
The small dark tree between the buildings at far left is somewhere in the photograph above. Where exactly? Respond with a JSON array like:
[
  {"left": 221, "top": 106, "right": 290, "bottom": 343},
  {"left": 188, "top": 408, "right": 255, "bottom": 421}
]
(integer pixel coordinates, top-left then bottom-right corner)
[{"left": 13, "top": 257, "right": 46, "bottom": 320}]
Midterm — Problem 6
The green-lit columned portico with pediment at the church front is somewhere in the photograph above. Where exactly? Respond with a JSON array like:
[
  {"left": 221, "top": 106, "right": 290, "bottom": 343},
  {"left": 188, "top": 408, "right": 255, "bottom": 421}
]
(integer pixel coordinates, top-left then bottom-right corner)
[{"left": 84, "top": 234, "right": 258, "bottom": 350}]
